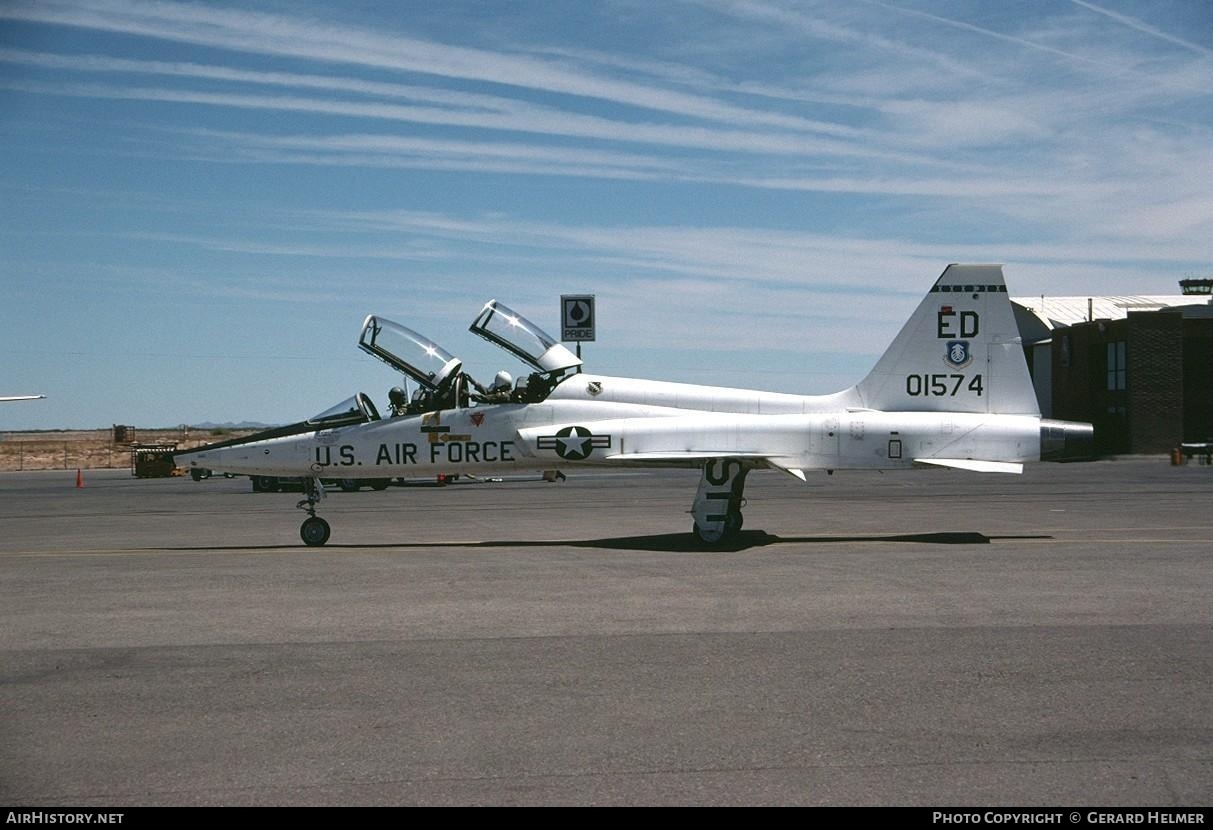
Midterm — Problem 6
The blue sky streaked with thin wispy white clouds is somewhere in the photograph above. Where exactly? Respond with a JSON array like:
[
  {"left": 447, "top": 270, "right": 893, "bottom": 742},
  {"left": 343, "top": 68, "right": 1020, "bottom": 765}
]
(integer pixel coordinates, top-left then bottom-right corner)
[{"left": 0, "top": 0, "right": 1213, "bottom": 430}]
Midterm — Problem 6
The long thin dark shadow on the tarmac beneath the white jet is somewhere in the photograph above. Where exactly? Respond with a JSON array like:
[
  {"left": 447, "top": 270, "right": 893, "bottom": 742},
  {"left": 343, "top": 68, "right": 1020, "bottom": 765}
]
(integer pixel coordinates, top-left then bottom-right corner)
[{"left": 161, "top": 530, "right": 1053, "bottom": 553}]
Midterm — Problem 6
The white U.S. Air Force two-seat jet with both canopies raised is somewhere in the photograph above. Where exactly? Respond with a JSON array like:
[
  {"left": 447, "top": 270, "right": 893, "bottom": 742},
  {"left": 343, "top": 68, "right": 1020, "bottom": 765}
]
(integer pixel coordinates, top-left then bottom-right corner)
[{"left": 177, "top": 265, "right": 1093, "bottom": 545}]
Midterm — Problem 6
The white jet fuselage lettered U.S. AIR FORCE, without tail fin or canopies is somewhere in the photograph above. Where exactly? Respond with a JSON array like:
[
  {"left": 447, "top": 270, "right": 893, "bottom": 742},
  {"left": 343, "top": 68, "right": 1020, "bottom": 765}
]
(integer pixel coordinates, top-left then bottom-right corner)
[{"left": 177, "top": 375, "right": 1041, "bottom": 478}]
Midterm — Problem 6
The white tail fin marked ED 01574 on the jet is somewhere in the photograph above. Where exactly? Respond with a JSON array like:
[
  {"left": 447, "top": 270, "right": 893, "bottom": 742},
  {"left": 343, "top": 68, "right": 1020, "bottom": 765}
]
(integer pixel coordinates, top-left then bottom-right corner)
[{"left": 855, "top": 265, "right": 1041, "bottom": 415}]
